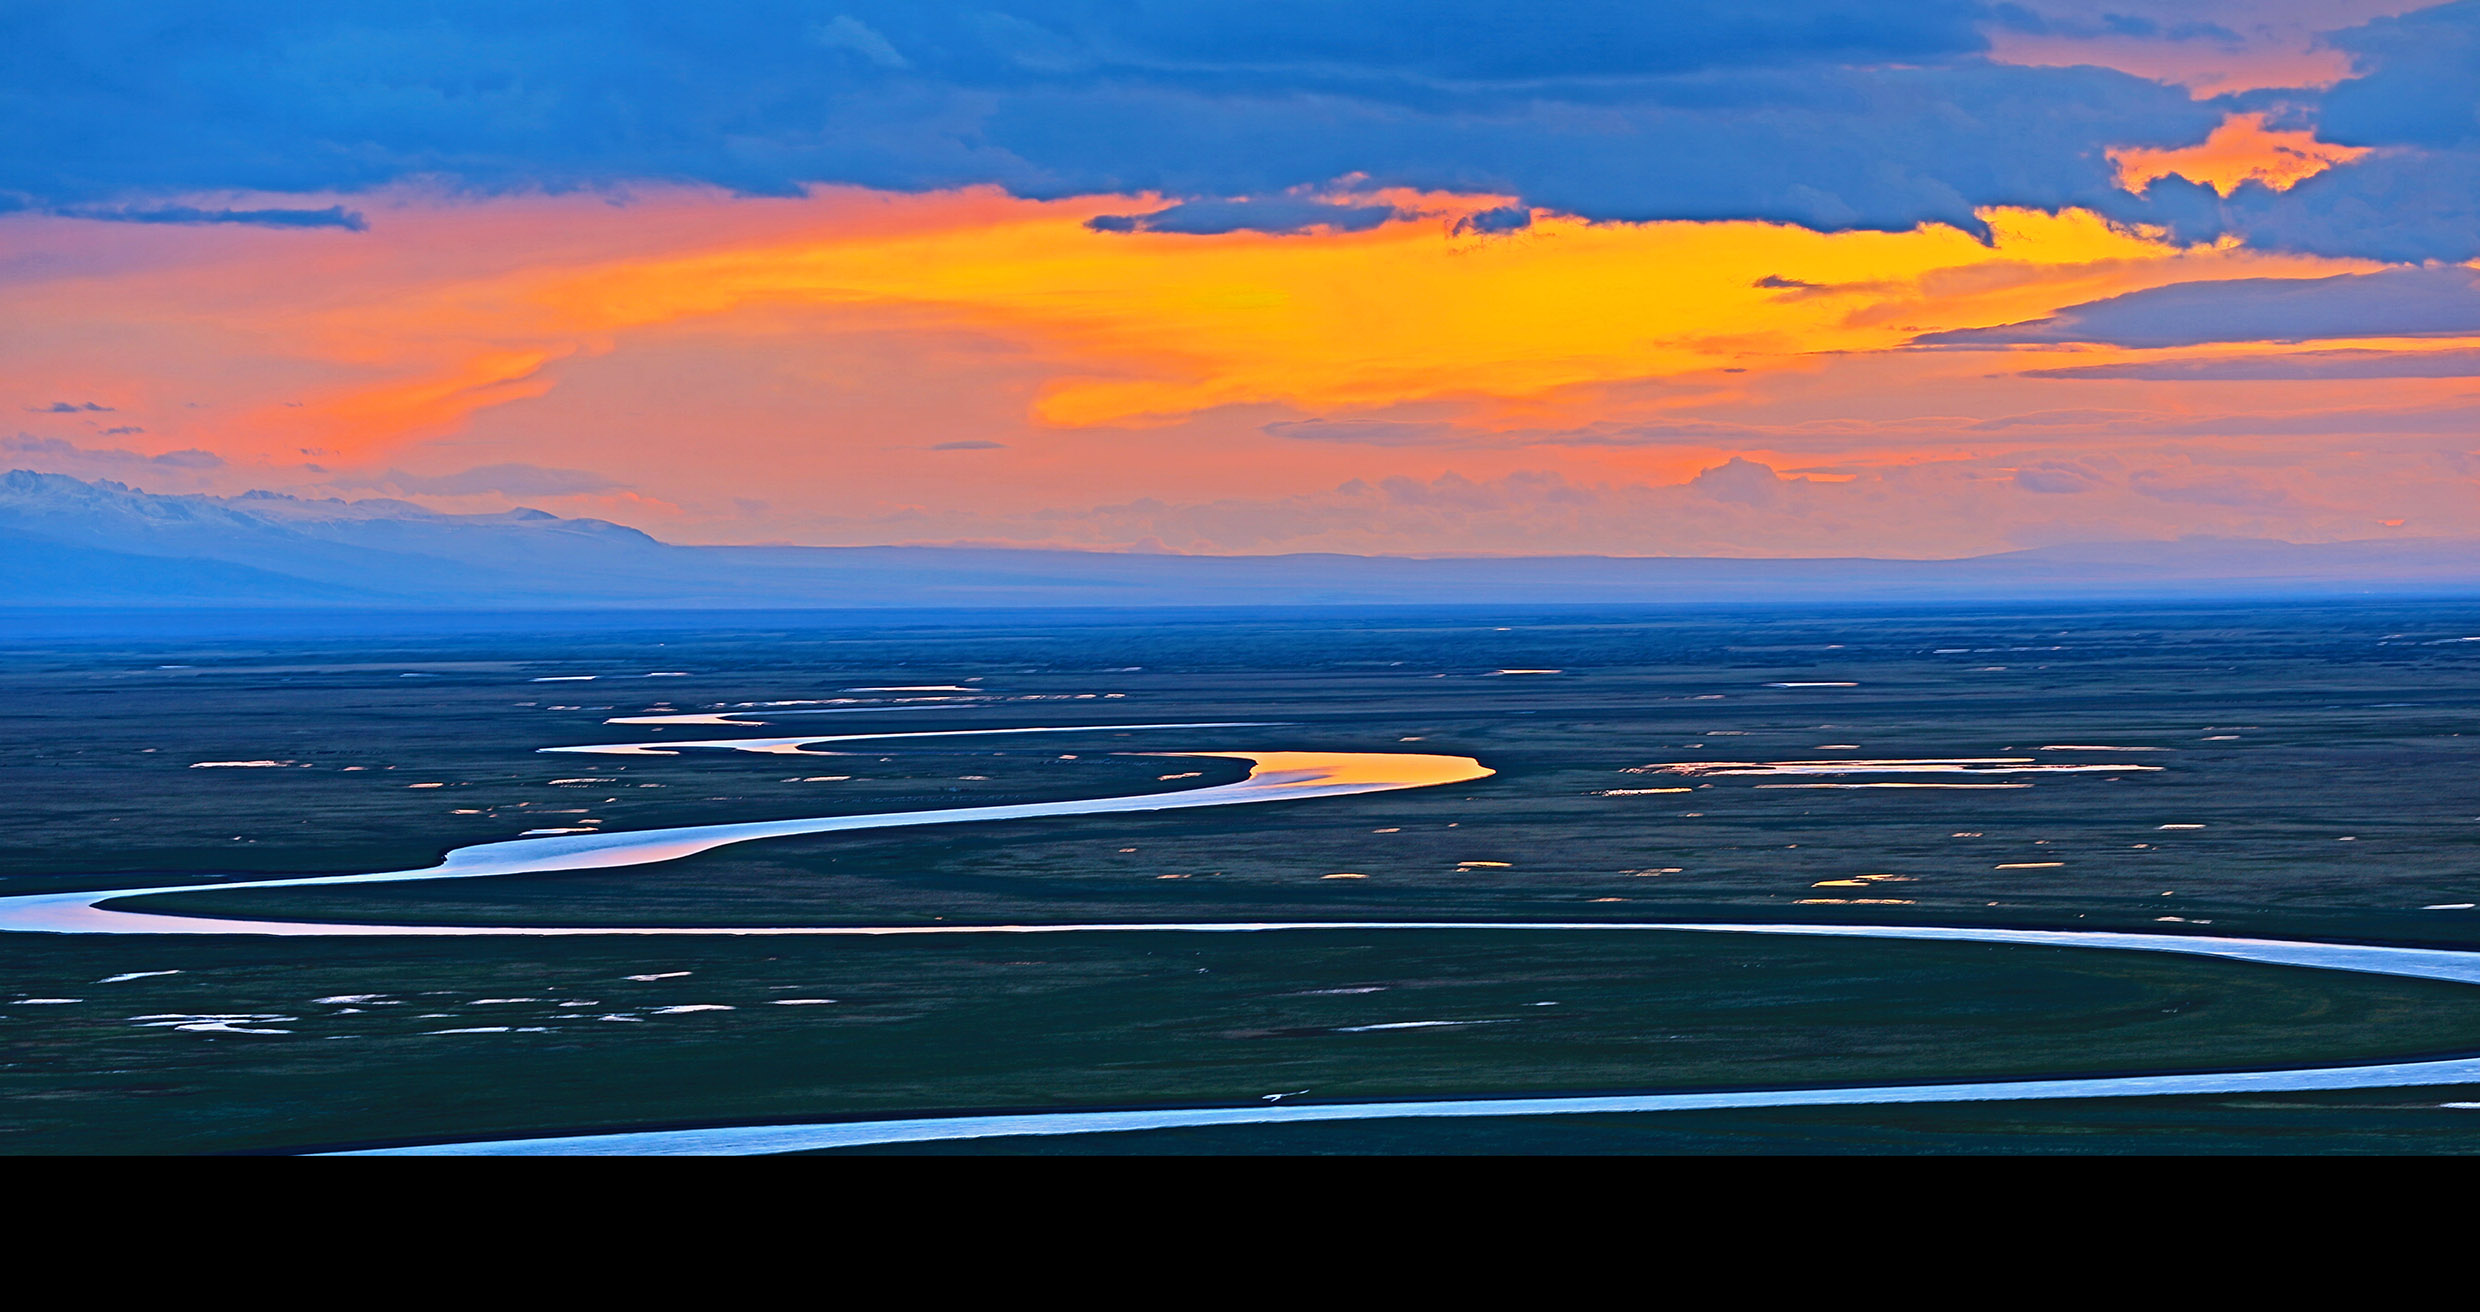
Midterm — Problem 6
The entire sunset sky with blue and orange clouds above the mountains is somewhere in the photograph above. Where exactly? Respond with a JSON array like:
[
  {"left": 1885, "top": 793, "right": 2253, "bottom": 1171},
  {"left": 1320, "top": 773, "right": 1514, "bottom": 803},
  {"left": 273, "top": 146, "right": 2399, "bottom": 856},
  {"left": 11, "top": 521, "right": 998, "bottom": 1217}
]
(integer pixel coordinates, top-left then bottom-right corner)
[{"left": 0, "top": 0, "right": 2480, "bottom": 558}]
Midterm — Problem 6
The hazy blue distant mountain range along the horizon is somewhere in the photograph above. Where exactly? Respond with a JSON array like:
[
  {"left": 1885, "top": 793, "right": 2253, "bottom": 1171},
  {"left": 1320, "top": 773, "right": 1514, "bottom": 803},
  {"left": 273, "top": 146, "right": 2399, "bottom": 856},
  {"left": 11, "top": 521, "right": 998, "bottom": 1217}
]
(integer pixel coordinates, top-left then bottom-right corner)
[{"left": 0, "top": 469, "right": 2480, "bottom": 610}]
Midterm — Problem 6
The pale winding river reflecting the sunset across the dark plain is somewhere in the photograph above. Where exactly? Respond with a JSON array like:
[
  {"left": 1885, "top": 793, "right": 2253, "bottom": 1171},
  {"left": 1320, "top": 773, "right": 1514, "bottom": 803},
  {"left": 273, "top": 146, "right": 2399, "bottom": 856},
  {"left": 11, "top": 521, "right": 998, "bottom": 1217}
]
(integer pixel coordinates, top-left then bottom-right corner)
[{"left": 0, "top": 709, "right": 2480, "bottom": 1156}]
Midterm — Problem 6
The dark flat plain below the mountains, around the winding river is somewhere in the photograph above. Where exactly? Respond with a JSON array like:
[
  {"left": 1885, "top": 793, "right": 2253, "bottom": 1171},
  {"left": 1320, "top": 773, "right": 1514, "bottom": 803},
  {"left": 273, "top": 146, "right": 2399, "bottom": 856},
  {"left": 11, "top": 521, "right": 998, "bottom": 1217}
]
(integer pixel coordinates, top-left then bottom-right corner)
[{"left": 0, "top": 603, "right": 2480, "bottom": 1153}]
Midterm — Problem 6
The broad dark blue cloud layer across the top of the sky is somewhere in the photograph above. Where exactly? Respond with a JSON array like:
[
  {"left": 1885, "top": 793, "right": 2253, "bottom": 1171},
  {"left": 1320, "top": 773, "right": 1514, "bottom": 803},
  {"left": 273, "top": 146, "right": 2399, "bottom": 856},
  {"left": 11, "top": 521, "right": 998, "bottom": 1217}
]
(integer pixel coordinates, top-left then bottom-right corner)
[{"left": 0, "top": 0, "right": 2480, "bottom": 258}]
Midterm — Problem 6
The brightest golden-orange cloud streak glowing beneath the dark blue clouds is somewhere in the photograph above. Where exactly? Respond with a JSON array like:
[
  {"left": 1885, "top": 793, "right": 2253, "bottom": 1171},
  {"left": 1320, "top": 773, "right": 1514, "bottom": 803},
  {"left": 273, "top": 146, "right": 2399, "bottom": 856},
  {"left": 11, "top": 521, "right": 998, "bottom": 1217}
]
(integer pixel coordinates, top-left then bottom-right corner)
[{"left": 164, "top": 181, "right": 2358, "bottom": 446}]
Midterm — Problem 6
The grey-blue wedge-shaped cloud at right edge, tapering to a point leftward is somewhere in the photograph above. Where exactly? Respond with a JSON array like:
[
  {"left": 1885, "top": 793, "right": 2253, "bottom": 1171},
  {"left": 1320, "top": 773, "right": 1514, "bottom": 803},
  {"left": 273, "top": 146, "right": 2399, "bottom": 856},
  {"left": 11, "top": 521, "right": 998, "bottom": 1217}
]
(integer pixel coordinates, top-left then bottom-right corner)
[{"left": 1915, "top": 268, "right": 2480, "bottom": 350}]
